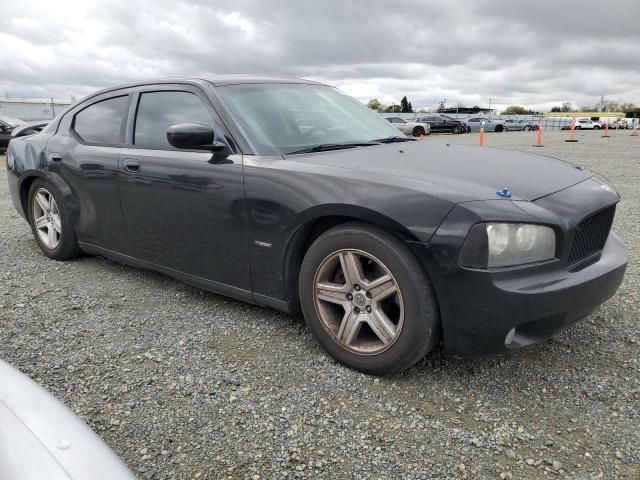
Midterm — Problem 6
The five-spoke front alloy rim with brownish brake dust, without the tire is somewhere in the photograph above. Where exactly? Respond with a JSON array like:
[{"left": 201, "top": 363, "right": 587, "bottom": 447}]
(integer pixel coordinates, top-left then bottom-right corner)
[{"left": 313, "top": 249, "right": 404, "bottom": 355}]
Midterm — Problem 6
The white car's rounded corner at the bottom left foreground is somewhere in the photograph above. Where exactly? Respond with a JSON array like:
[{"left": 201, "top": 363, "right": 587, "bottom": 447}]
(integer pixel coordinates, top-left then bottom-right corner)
[{"left": 0, "top": 360, "right": 135, "bottom": 480}]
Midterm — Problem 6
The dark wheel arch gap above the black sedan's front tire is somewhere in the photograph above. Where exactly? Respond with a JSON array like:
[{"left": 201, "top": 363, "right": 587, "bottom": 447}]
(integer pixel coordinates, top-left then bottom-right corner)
[{"left": 283, "top": 205, "right": 428, "bottom": 311}]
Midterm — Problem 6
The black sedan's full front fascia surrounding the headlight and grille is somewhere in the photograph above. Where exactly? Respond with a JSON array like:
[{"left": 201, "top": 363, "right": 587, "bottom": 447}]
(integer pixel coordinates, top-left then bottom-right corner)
[{"left": 413, "top": 179, "right": 627, "bottom": 356}]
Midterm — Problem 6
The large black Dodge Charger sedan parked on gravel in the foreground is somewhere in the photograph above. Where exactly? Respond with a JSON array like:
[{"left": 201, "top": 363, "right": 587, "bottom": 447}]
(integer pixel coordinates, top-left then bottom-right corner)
[{"left": 7, "top": 76, "right": 627, "bottom": 375}]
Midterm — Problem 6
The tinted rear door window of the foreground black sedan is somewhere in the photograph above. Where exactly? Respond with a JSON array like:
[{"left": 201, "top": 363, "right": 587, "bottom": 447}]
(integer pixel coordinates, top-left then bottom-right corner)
[{"left": 73, "top": 95, "right": 128, "bottom": 144}]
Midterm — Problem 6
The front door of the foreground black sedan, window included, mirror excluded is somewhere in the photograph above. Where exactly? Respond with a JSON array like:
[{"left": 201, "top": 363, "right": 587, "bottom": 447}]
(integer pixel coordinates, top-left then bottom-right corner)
[{"left": 120, "top": 84, "right": 250, "bottom": 290}]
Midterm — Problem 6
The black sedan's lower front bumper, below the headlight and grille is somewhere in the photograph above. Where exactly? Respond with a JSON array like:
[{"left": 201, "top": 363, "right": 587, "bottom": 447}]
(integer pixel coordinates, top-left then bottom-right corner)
[{"left": 436, "top": 232, "right": 627, "bottom": 356}]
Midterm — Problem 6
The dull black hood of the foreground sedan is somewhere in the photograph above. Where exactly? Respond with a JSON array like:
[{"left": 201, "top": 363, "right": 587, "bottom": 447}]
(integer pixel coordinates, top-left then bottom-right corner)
[{"left": 287, "top": 141, "right": 592, "bottom": 202}]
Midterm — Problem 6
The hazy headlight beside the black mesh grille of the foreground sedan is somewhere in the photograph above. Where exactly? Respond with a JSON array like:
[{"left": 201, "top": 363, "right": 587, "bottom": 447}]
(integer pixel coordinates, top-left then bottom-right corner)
[{"left": 460, "top": 222, "right": 556, "bottom": 268}]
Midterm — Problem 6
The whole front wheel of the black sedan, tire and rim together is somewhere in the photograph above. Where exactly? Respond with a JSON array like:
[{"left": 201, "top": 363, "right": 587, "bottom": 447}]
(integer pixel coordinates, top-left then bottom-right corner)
[{"left": 299, "top": 222, "right": 440, "bottom": 375}]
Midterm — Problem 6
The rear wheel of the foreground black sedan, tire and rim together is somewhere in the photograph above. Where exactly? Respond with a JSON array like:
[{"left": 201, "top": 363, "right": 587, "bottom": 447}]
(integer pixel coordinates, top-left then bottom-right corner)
[{"left": 27, "top": 179, "right": 81, "bottom": 260}]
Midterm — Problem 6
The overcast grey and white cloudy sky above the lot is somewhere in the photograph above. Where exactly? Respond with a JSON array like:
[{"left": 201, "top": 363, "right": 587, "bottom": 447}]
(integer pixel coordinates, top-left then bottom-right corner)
[{"left": 0, "top": 0, "right": 640, "bottom": 109}]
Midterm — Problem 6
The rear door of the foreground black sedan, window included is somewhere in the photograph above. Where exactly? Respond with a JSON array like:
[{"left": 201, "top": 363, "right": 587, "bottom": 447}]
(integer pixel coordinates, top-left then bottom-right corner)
[{"left": 46, "top": 90, "right": 131, "bottom": 253}]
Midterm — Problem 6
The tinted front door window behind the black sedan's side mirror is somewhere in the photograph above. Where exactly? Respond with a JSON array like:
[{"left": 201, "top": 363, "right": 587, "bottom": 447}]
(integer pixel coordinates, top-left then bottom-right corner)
[{"left": 133, "top": 92, "right": 214, "bottom": 148}]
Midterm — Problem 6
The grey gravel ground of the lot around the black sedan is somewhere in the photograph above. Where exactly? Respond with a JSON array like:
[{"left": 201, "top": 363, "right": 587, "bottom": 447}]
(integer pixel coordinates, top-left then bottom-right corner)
[{"left": 0, "top": 131, "right": 640, "bottom": 479}]
